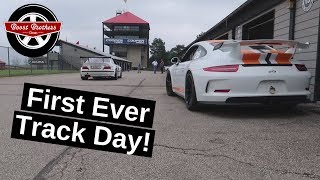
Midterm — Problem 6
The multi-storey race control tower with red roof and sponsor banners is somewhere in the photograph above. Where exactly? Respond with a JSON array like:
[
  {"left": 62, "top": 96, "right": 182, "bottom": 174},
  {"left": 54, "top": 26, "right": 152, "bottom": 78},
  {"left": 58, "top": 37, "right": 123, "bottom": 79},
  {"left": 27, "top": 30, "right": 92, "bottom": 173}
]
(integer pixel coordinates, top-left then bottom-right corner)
[{"left": 102, "top": 11, "right": 150, "bottom": 68}]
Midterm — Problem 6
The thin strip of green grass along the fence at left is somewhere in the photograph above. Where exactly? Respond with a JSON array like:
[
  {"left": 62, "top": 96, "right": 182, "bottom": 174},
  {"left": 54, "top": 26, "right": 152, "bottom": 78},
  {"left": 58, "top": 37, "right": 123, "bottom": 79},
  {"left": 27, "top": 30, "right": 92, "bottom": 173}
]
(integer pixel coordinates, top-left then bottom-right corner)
[{"left": 0, "top": 69, "right": 79, "bottom": 77}]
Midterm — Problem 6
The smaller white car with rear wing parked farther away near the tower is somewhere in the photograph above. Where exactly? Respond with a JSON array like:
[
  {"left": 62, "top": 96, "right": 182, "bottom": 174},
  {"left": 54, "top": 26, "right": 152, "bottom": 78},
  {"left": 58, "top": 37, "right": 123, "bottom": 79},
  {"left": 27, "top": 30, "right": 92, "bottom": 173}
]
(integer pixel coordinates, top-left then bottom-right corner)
[{"left": 80, "top": 56, "right": 122, "bottom": 80}]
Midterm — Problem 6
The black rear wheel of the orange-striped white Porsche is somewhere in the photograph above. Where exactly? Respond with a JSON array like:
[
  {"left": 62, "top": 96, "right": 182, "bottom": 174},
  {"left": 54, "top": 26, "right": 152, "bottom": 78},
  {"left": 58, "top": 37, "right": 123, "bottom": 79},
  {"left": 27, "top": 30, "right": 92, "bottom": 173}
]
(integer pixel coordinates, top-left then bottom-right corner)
[{"left": 185, "top": 72, "right": 198, "bottom": 111}]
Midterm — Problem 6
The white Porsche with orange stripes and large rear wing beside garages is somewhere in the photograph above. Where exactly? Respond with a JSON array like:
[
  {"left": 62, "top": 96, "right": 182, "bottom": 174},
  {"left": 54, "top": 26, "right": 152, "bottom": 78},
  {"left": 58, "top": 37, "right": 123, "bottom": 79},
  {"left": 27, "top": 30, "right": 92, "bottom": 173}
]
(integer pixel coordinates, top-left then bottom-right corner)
[{"left": 166, "top": 40, "right": 311, "bottom": 110}]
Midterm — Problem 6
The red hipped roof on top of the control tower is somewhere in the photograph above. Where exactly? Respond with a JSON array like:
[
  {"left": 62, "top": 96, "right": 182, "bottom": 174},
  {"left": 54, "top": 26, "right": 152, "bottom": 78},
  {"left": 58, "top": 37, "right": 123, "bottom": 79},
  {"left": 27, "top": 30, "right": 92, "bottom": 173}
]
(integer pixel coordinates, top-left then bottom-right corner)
[{"left": 103, "top": 12, "right": 149, "bottom": 24}]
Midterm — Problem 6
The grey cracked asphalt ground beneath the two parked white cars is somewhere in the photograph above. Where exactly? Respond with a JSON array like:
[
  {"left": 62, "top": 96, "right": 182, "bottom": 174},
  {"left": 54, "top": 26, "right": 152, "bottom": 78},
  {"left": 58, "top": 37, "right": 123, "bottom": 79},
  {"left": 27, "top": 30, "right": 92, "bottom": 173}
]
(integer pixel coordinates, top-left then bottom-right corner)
[{"left": 0, "top": 71, "right": 320, "bottom": 180}]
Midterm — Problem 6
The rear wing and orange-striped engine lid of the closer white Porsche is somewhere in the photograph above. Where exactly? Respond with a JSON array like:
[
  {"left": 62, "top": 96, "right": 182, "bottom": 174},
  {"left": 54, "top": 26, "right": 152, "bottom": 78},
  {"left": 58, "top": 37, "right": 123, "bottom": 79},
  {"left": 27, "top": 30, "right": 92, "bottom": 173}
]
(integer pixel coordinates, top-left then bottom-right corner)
[{"left": 210, "top": 40, "right": 309, "bottom": 65}]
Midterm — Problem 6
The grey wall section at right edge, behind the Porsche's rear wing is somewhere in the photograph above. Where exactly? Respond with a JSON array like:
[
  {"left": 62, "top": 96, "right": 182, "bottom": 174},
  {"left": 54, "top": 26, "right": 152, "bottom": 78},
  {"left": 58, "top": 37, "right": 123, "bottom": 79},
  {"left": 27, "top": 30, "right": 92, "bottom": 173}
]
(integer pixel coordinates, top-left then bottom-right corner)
[{"left": 294, "top": 0, "right": 320, "bottom": 100}]
